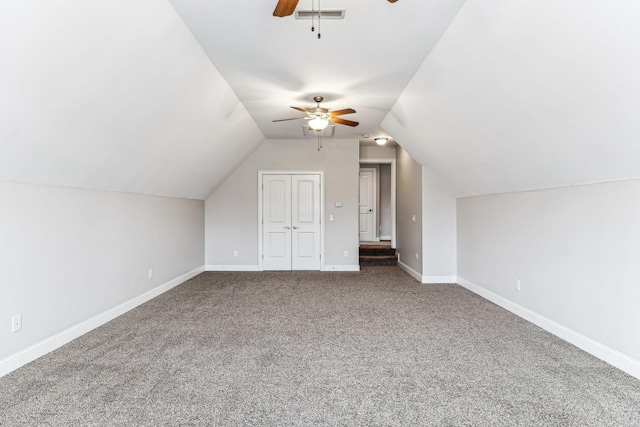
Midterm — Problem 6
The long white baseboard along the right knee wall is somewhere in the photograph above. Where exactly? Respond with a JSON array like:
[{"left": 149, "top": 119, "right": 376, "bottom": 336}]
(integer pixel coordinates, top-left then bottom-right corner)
[{"left": 457, "top": 276, "right": 640, "bottom": 379}]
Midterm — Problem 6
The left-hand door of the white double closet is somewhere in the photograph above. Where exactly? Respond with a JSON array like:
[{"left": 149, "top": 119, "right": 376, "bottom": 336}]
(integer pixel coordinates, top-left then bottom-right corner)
[{"left": 262, "top": 175, "right": 292, "bottom": 270}]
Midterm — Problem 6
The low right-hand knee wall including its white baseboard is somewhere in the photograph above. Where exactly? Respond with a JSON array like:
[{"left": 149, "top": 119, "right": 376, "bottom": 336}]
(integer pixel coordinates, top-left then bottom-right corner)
[{"left": 457, "top": 180, "right": 640, "bottom": 378}]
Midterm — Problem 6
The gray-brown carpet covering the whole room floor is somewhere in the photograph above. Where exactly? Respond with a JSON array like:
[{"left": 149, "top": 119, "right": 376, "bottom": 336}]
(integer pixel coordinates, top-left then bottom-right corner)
[{"left": 0, "top": 267, "right": 640, "bottom": 426}]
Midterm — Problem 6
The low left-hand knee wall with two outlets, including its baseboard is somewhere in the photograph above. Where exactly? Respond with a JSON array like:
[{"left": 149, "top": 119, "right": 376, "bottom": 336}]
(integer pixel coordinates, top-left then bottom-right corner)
[{"left": 0, "top": 182, "right": 204, "bottom": 375}]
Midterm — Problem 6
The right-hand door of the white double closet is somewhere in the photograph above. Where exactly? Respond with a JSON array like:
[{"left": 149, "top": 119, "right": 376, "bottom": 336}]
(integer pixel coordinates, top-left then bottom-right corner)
[{"left": 291, "top": 174, "right": 320, "bottom": 270}]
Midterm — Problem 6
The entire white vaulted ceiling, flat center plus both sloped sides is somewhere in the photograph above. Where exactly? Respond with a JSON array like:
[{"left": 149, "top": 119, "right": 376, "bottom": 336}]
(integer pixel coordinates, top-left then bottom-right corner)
[{"left": 0, "top": 0, "right": 640, "bottom": 198}]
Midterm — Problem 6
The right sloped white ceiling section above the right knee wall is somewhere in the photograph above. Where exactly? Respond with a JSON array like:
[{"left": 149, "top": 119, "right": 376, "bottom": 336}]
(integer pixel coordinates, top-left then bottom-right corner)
[{"left": 382, "top": 0, "right": 640, "bottom": 196}]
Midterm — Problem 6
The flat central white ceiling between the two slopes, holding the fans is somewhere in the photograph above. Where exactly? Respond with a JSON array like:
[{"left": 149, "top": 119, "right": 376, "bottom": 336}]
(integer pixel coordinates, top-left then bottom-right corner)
[{"left": 169, "top": 0, "right": 464, "bottom": 139}]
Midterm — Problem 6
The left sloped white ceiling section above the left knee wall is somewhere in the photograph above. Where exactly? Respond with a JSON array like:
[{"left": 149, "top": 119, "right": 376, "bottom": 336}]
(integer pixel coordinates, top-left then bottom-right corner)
[{"left": 0, "top": 0, "right": 264, "bottom": 199}]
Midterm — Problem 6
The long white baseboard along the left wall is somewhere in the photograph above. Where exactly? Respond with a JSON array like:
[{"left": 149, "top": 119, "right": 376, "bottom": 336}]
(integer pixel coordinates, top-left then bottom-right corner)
[{"left": 0, "top": 267, "right": 204, "bottom": 377}]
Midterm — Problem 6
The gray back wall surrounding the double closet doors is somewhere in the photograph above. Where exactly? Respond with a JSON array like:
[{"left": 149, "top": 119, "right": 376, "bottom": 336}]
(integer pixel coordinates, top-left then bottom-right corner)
[{"left": 205, "top": 139, "right": 359, "bottom": 270}]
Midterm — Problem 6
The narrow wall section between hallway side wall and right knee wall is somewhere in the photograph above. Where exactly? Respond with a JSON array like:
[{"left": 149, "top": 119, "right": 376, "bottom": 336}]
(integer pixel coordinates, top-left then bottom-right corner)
[{"left": 422, "top": 166, "right": 458, "bottom": 283}]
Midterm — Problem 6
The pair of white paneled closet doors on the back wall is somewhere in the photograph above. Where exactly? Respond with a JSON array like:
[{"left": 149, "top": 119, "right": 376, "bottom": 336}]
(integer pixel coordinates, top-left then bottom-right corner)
[{"left": 262, "top": 174, "right": 321, "bottom": 270}]
